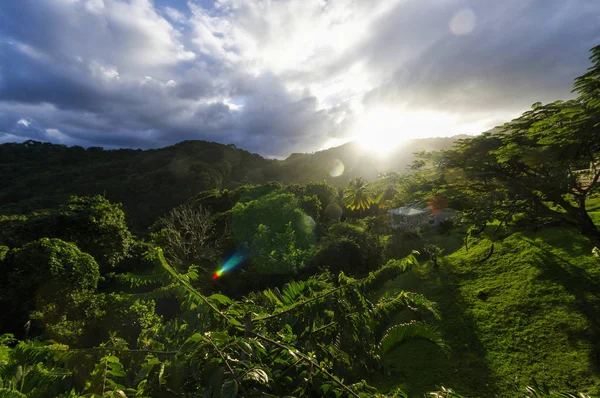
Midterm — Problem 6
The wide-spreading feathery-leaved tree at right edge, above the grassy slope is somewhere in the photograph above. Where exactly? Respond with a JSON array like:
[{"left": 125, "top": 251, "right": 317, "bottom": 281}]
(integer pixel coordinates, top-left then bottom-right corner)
[{"left": 436, "top": 46, "right": 600, "bottom": 245}]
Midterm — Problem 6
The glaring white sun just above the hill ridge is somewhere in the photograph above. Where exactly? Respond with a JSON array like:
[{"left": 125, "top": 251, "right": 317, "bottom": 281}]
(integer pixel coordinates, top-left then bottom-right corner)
[{"left": 354, "top": 108, "right": 453, "bottom": 154}]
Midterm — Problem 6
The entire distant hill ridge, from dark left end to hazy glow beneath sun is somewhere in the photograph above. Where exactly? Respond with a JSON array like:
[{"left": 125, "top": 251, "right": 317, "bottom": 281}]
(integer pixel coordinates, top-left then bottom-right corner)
[{"left": 0, "top": 138, "right": 464, "bottom": 232}]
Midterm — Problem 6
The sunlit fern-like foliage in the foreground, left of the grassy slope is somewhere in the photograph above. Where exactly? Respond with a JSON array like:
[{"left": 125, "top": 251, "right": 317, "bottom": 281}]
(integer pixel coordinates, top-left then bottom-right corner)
[{"left": 0, "top": 249, "right": 446, "bottom": 397}]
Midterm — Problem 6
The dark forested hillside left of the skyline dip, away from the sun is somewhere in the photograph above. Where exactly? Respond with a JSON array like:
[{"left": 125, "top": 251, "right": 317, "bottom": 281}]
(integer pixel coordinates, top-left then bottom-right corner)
[{"left": 0, "top": 141, "right": 273, "bottom": 229}]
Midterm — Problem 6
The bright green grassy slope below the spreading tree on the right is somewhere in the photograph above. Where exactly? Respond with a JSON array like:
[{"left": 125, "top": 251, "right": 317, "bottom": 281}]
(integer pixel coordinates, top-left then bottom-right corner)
[{"left": 374, "top": 200, "right": 600, "bottom": 397}]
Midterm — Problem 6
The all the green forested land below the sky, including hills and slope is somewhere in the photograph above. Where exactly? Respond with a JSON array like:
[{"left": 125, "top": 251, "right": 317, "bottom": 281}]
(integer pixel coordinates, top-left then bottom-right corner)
[{"left": 0, "top": 46, "right": 600, "bottom": 397}]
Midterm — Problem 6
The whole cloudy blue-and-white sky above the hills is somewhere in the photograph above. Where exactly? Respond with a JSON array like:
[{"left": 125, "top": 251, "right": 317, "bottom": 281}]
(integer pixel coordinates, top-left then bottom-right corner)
[{"left": 0, "top": 0, "right": 600, "bottom": 157}]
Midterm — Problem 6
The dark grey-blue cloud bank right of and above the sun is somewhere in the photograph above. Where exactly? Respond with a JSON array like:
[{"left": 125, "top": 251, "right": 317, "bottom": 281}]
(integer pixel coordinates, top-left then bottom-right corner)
[{"left": 365, "top": 0, "right": 600, "bottom": 114}]
